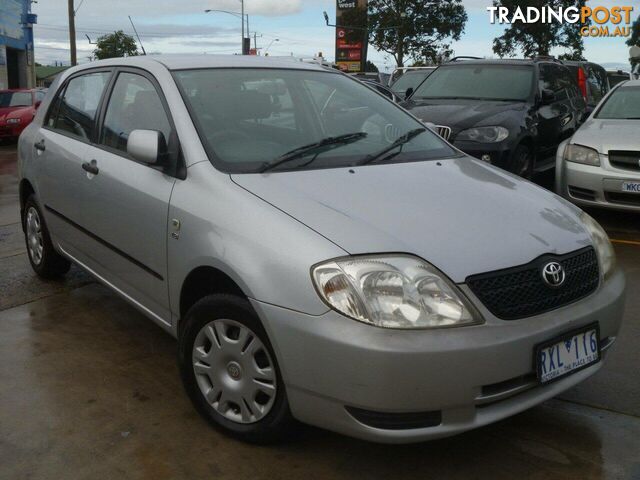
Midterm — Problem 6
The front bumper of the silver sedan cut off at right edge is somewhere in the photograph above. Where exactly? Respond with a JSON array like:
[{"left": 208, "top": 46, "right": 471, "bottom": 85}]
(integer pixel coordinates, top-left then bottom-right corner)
[{"left": 556, "top": 153, "right": 640, "bottom": 212}]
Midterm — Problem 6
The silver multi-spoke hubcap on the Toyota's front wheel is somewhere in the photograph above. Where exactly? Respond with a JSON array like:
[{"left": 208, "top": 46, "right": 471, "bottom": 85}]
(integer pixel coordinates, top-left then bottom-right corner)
[{"left": 192, "top": 319, "right": 276, "bottom": 424}]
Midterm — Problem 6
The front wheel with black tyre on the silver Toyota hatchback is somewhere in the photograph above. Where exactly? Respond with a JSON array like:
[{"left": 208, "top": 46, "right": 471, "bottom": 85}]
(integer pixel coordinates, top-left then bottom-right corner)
[{"left": 178, "top": 294, "right": 295, "bottom": 443}]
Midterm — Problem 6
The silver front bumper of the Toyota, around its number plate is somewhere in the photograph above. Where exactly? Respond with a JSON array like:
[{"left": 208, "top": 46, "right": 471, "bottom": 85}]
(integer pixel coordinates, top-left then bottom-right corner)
[{"left": 252, "top": 270, "right": 625, "bottom": 443}]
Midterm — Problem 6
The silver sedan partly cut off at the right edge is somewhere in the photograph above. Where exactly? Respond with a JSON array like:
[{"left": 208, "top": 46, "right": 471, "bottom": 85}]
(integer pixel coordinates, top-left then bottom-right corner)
[{"left": 556, "top": 80, "right": 640, "bottom": 211}]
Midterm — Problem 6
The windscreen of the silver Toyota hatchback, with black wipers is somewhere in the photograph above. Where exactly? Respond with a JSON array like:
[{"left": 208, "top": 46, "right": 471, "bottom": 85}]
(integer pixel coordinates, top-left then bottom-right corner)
[{"left": 174, "top": 68, "right": 459, "bottom": 173}]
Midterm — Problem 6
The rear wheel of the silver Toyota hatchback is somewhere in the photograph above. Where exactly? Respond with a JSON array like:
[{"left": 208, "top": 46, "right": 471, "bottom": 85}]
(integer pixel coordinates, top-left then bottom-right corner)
[{"left": 22, "top": 195, "right": 71, "bottom": 280}]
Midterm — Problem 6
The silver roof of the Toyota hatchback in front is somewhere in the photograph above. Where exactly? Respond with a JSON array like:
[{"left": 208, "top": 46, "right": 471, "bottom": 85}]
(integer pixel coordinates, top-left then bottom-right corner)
[{"left": 72, "top": 54, "right": 337, "bottom": 72}]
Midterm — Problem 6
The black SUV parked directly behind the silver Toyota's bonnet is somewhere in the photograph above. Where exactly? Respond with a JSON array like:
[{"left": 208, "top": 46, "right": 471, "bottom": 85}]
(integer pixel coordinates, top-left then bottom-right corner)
[{"left": 402, "top": 59, "right": 586, "bottom": 177}]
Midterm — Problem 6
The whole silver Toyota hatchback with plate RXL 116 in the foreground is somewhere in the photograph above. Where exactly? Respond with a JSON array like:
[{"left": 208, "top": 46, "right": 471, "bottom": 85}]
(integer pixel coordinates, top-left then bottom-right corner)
[{"left": 19, "top": 56, "right": 625, "bottom": 442}]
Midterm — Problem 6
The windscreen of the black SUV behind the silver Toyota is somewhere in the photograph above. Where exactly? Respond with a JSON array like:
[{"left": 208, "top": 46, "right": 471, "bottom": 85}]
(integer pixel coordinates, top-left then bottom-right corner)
[{"left": 412, "top": 64, "right": 534, "bottom": 101}]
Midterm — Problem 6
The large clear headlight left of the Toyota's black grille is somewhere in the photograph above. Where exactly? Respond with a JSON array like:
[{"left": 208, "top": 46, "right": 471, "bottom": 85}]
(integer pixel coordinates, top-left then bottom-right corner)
[{"left": 311, "top": 255, "right": 482, "bottom": 328}]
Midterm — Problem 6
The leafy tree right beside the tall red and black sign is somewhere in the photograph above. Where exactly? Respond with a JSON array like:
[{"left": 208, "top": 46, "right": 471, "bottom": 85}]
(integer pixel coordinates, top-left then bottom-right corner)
[{"left": 368, "top": 0, "right": 467, "bottom": 67}]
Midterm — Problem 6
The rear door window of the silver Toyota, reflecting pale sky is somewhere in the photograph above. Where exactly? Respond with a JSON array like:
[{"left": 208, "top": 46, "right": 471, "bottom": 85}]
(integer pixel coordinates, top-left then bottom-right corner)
[{"left": 47, "top": 72, "right": 111, "bottom": 140}]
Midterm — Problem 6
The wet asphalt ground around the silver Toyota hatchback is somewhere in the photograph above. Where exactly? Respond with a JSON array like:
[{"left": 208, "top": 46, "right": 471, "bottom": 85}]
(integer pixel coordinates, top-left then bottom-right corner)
[{"left": 0, "top": 145, "right": 640, "bottom": 480}]
